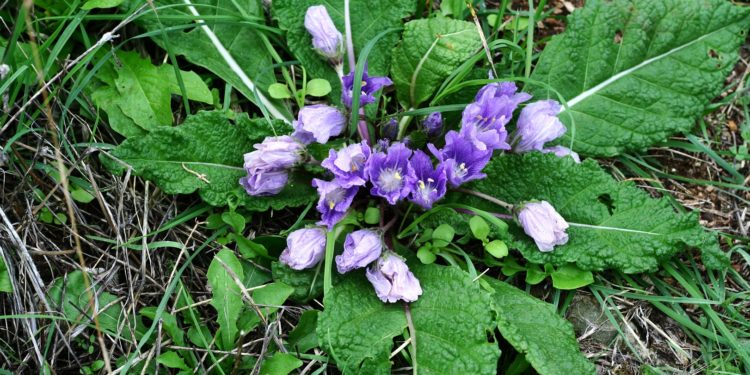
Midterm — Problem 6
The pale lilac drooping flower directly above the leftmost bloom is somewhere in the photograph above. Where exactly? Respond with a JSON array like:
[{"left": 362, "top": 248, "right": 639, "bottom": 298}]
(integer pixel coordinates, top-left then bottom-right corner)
[{"left": 244, "top": 135, "right": 305, "bottom": 171}]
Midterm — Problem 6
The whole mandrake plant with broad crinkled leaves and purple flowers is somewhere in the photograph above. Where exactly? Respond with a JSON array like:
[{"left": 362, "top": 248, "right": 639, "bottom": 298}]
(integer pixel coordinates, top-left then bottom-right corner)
[{"left": 2, "top": 0, "right": 750, "bottom": 374}]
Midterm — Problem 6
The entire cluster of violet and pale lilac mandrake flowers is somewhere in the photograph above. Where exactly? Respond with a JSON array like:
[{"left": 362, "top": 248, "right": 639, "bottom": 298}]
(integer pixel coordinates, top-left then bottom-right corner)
[{"left": 240, "top": 6, "right": 579, "bottom": 302}]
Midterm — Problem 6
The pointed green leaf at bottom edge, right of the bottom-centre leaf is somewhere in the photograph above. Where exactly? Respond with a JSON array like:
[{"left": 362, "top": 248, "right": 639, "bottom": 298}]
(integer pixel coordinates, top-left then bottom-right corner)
[{"left": 484, "top": 278, "right": 596, "bottom": 375}]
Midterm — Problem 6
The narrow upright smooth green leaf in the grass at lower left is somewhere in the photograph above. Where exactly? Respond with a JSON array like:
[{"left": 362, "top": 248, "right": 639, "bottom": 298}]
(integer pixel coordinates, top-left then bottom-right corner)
[{"left": 207, "top": 250, "right": 244, "bottom": 350}]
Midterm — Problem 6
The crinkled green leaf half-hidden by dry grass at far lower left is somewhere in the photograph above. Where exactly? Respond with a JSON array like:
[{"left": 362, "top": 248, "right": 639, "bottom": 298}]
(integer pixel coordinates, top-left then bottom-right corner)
[{"left": 49, "top": 271, "right": 123, "bottom": 335}]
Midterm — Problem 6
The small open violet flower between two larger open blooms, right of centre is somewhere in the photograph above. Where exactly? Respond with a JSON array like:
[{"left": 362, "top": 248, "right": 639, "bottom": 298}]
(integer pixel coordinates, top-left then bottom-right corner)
[{"left": 409, "top": 150, "right": 447, "bottom": 209}]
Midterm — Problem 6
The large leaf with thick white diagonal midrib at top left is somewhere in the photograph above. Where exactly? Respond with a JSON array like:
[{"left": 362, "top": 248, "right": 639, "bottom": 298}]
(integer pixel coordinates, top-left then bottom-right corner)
[{"left": 123, "top": 0, "right": 289, "bottom": 119}]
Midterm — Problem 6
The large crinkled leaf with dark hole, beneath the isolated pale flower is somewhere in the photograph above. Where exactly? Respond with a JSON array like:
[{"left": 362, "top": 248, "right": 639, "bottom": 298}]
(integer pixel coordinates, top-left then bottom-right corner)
[{"left": 451, "top": 152, "right": 725, "bottom": 273}]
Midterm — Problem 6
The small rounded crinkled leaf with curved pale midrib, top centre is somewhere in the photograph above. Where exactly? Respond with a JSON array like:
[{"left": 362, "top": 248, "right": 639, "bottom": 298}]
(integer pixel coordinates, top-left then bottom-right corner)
[{"left": 391, "top": 17, "right": 482, "bottom": 108}]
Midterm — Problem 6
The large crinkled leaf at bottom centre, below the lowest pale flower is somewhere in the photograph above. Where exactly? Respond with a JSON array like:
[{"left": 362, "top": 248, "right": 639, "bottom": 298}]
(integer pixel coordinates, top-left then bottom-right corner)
[{"left": 317, "top": 265, "right": 500, "bottom": 374}]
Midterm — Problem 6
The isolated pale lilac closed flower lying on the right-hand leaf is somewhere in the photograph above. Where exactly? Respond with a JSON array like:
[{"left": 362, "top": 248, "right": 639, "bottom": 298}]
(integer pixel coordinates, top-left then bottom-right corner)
[{"left": 518, "top": 201, "right": 568, "bottom": 252}]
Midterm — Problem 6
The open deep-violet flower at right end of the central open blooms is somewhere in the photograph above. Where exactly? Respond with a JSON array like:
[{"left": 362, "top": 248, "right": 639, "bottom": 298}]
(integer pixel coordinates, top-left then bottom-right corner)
[{"left": 427, "top": 130, "right": 492, "bottom": 187}]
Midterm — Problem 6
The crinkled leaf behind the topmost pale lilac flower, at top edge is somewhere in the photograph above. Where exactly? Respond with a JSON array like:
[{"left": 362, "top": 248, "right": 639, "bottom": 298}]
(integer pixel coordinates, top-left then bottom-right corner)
[{"left": 273, "top": 0, "right": 416, "bottom": 101}]
